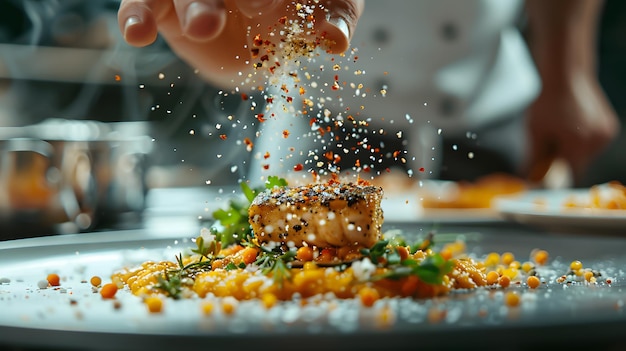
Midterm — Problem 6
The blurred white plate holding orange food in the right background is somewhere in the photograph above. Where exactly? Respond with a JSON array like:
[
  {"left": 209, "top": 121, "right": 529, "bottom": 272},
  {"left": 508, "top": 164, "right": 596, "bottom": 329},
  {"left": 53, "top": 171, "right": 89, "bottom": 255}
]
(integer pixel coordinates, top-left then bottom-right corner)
[{"left": 494, "top": 189, "right": 626, "bottom": 234}]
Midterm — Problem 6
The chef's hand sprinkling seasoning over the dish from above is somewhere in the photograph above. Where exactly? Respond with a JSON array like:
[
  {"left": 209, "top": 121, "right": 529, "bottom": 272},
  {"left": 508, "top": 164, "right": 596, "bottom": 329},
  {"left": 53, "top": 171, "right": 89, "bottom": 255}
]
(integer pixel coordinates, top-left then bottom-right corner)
[{"left": 118, "top": 0, "right": 363, "bottom": 87}]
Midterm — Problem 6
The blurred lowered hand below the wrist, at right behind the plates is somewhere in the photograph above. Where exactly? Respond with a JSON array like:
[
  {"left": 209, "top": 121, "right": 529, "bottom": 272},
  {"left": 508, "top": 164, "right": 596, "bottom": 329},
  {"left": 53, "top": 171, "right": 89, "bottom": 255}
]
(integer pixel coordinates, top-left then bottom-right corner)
[{"left": 528, "top": 73, "right": 619, "bottom": 183}]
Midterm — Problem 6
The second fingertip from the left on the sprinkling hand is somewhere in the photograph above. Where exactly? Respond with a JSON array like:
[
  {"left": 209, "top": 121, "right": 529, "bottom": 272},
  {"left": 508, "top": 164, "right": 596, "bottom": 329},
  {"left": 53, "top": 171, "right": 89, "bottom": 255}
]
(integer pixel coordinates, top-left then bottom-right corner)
[{"left": 174, "top": 0, "right": 226, "bottom": 42}]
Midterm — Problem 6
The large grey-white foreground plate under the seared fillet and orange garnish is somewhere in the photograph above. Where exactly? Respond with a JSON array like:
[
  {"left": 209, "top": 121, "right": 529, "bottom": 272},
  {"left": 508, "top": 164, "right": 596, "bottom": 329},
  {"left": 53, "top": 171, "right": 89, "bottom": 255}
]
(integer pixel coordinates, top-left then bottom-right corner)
[{"left": 0, "top": 225, "right": 626, "bottom": 350}]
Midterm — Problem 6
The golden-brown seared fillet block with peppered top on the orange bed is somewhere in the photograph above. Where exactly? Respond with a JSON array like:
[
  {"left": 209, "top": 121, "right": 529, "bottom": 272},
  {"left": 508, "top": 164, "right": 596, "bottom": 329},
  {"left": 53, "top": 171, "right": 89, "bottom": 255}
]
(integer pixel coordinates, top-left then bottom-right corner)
[{"left": 248, "top": 181, "right": 383, "bottom": 247}]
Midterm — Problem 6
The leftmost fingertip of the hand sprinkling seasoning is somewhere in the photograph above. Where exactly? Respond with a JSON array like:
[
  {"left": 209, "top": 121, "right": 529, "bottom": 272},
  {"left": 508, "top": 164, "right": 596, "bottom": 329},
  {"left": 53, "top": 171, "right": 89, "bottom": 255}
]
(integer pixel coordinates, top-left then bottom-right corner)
[{"left": 117, "top": 0, "right": 171, "bottom": 47}]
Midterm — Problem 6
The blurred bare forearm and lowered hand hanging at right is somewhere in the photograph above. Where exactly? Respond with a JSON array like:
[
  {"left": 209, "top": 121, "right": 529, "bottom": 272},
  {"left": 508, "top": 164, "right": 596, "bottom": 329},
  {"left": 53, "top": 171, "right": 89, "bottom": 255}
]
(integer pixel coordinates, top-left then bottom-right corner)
[{"left": 526, "top": 0, "right": 619, "bottom": 185}]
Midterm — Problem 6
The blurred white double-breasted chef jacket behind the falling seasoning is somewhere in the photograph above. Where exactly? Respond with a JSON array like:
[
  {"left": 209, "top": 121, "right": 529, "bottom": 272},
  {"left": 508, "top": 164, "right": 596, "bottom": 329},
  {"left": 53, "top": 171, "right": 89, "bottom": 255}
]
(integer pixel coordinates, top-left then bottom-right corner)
[{"left": 251, "top": 0, "right": 540, "bottom": 183}]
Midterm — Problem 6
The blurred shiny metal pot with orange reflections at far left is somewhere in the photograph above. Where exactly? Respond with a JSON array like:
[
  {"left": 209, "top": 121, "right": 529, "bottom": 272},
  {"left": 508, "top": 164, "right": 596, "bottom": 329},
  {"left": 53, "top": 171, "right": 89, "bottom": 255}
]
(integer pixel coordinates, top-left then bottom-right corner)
[{"left": 0, "top": 119, "right": 152, "bottom": 239}]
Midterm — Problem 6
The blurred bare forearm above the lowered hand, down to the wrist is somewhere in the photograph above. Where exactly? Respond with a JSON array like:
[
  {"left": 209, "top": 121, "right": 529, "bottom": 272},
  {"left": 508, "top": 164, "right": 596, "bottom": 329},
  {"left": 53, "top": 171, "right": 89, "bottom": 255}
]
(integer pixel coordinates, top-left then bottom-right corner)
[{"left": 526, "top": 0, "right": 603, "bottom": 85}]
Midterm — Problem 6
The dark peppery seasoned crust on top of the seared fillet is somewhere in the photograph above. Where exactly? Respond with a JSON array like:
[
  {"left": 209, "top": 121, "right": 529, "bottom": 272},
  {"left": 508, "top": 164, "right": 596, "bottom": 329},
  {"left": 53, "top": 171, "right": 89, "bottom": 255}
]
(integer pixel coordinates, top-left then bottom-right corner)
[{"left": 252, "top": 183, "right": 383, "bottom": 207}]
